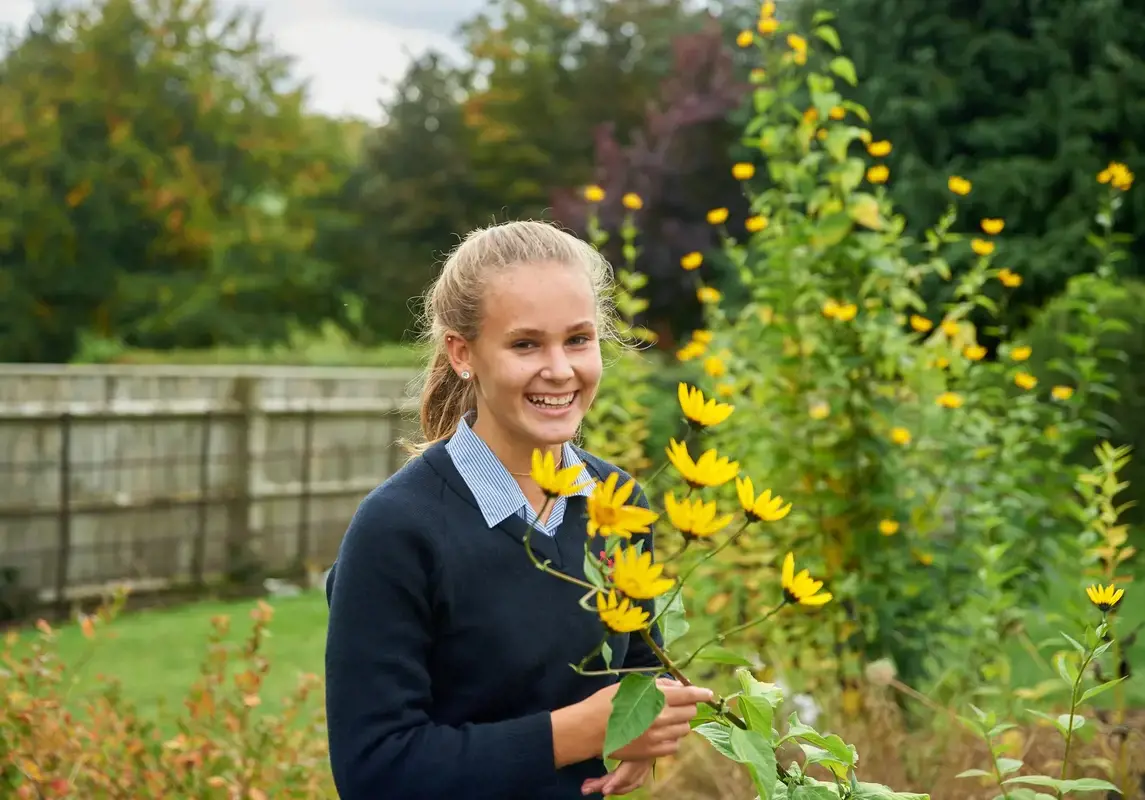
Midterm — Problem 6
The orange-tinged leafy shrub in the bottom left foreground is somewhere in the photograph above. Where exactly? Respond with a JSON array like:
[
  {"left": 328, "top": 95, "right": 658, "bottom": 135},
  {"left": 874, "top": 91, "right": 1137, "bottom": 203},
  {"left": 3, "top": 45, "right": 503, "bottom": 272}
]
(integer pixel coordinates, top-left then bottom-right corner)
[{"left": 0, "top": 595, "right": 333, "bottom": 800}]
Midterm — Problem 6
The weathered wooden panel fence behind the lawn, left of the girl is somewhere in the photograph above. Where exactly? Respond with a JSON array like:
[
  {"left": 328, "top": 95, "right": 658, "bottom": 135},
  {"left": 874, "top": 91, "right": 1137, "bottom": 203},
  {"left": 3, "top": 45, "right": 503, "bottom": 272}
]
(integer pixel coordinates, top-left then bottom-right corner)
[{"left": 0, "top": 365, "right": 416, "bottom": 604}]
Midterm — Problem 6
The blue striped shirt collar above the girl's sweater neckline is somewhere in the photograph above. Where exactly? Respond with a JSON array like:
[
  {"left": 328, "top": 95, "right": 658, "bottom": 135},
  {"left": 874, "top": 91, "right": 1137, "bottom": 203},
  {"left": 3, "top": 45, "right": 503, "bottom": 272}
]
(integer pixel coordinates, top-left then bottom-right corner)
[{"left": 445, "top": 419, "right": 592, "bottom": 536}]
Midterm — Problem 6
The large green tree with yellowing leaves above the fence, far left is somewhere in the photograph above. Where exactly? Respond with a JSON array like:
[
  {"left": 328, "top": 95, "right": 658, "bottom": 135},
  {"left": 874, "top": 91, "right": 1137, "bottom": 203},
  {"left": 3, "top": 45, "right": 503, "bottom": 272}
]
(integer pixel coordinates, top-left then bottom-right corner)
[{"left": 0, "top": 0, "right": 345, "bottom": 362}]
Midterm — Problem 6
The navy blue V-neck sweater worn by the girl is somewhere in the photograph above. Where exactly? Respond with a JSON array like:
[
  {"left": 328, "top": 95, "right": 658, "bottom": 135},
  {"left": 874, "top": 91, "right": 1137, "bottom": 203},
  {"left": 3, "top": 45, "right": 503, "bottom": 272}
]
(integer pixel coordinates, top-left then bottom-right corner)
[{"left": 326, "top": 443, "right": 660, "bottom": 800}]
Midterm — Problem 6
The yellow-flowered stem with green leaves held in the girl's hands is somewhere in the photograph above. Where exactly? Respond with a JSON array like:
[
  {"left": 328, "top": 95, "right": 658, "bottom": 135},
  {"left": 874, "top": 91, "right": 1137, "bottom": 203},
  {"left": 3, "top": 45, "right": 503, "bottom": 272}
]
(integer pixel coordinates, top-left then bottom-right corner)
[{"left": 524, "top": 383, "right": 929, "bottom": 799}]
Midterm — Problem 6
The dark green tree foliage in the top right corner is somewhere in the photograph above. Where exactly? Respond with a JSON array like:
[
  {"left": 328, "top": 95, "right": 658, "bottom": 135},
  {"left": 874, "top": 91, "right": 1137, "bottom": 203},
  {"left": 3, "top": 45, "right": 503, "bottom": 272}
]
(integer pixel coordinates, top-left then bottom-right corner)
[{"left": 806, "top": 0, "right": 1145, "bottom": 324}]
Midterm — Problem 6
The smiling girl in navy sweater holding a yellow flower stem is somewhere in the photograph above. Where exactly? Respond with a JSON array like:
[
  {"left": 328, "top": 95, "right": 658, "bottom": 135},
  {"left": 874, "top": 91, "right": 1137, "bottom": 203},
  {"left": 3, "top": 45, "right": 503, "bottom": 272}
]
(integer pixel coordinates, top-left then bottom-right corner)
[{"left": 326, "top": 222, "right": 711, "bottom": 800}]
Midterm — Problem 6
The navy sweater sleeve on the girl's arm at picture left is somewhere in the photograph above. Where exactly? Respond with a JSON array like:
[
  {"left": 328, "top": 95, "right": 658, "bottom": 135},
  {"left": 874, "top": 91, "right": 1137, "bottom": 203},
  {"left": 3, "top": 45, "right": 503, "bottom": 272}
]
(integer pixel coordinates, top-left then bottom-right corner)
[{"left": 326, "top": 489, "right": 556, "bottom": 800}]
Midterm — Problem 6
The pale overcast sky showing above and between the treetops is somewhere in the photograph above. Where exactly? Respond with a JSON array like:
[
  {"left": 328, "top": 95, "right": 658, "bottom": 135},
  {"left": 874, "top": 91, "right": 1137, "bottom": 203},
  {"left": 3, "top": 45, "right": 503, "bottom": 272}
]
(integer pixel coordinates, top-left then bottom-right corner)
[{"left": 0, "top": 0, "right": 483, "bottom": 121}]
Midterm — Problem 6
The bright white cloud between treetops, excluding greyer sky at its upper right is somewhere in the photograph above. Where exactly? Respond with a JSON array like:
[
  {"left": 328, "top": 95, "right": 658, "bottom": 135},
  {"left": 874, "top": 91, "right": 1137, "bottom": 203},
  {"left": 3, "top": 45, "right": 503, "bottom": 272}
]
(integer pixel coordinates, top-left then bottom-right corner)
[{"left": 0, "top": 0, "right": 458, "bottom": 121}]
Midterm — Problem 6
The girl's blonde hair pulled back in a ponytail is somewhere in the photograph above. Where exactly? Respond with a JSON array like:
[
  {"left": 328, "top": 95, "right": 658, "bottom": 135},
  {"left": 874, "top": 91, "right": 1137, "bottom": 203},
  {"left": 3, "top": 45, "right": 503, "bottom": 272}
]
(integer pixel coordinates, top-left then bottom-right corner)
[{"left": 406, "top": 221, "right": 617, "bottom": 453}]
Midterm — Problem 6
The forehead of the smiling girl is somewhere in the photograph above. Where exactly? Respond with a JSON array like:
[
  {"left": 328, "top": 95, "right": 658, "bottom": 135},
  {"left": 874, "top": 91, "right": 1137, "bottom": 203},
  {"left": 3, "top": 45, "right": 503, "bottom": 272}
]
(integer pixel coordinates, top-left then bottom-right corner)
[{"left": 482, "top": 262, "right": 597, "bottom": 333}]
